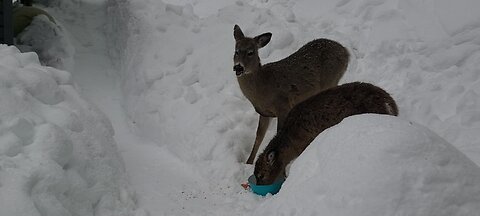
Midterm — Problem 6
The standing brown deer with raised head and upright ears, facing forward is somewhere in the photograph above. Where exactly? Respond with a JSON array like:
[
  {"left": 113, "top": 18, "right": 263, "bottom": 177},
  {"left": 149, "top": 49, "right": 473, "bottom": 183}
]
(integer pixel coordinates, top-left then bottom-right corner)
[{"left": 233, "top": 25, "right": 349, "bottom": 164}]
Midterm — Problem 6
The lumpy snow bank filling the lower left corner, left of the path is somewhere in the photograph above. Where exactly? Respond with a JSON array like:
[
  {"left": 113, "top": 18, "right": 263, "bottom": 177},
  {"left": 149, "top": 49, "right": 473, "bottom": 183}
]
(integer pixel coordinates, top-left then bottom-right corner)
[{"left": 0, "top": 45, "right": 136, "bottom": 216}]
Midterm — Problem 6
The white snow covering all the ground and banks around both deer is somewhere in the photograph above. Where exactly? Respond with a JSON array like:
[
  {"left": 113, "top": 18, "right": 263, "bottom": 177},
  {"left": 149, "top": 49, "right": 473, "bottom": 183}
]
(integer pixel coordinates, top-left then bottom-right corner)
[{"left": 0, "top": 0, "right": 480, "bottom": 216}]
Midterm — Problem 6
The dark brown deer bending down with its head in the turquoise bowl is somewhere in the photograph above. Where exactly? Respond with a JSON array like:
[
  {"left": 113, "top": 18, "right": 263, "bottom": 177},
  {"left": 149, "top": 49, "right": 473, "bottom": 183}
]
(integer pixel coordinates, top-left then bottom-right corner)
[{"left": 254, "top": 82, "right": 398, "bottom": 184}]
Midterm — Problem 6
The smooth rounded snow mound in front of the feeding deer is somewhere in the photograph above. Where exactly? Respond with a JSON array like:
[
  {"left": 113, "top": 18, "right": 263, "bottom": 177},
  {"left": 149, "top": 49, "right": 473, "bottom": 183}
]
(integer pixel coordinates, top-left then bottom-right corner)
[{"left": 255, "top": 114, "right": 480, "bottom": 216}]
